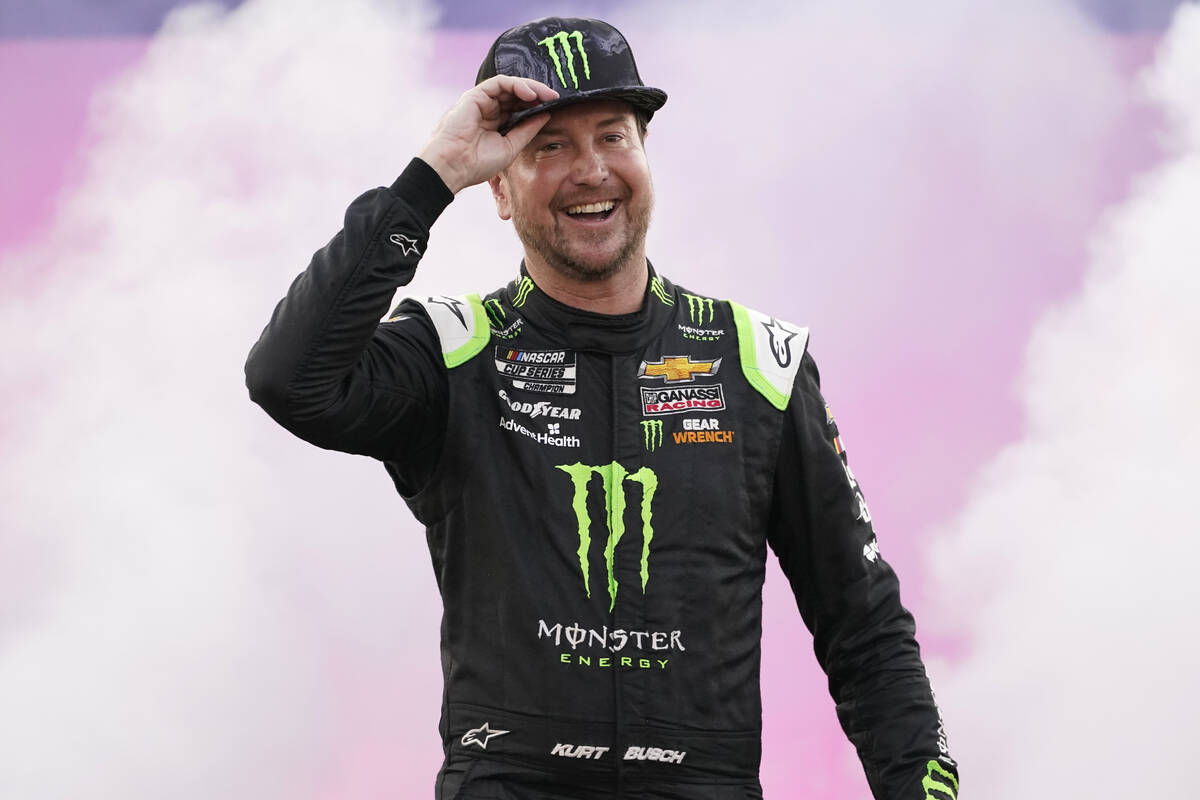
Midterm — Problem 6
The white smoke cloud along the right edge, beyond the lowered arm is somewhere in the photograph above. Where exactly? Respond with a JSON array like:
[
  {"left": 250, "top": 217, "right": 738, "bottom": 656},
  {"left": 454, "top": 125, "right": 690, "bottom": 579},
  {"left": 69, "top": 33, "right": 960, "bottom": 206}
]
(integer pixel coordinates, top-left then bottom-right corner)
[{"left": 936, "top": 5, "right": 1200, "bottom": 800}]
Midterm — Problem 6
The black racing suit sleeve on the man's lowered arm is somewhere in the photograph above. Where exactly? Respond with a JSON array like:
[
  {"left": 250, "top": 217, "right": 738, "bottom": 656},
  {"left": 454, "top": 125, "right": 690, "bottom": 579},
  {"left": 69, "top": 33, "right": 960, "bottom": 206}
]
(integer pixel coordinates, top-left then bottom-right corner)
[{"left": 768, "top": 354, "right": 958, "bottom": 800}]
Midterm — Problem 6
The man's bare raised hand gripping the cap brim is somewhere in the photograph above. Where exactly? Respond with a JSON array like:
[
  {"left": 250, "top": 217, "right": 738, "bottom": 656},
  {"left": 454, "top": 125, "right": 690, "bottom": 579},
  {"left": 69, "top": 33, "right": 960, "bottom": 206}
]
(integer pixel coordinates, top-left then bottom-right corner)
[{"left": 420, "top": 76, "right": 558, "bottom": 194}]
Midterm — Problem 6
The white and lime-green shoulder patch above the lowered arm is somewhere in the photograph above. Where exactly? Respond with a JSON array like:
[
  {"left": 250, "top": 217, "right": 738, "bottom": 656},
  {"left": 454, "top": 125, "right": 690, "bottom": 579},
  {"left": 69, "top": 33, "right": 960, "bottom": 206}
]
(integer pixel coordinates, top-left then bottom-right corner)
[{"left": 730, "top": 300, "right": 809, "bottom": 411}]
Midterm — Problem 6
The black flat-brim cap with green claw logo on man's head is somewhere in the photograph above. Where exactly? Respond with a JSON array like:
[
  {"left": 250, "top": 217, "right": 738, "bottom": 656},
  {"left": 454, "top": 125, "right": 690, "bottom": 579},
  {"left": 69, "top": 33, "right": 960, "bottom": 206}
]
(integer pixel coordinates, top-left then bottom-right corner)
[{"left": 475, "top": 17, "right": 667, "bottom": 133}]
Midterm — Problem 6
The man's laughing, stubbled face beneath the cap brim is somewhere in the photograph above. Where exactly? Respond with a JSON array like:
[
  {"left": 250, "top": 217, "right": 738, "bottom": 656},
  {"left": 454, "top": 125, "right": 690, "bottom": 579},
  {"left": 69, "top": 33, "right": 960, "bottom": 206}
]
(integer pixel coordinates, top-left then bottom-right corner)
[{"left": 491, "top": 101, "right": 654, "bottom": 282}]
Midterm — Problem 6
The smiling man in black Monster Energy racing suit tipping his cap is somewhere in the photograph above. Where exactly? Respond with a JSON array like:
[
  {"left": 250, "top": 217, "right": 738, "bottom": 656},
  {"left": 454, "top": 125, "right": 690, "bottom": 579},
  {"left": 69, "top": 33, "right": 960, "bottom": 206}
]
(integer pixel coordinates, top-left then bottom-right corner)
[{"left": 246, "top": 18, "right": 958, "bottom": 800}]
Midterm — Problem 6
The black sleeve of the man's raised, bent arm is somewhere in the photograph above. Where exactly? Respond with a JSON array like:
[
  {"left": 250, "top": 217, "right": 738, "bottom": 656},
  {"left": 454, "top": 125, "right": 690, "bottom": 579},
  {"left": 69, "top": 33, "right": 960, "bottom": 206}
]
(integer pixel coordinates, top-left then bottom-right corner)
[{"left": 246, "top": 158, "right": 454, "bottom": 492}]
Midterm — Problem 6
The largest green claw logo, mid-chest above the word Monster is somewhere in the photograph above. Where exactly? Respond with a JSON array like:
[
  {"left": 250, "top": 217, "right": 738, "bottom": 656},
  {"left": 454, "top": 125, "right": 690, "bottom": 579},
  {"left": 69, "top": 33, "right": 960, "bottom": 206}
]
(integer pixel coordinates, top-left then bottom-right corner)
[{"left": 557, "top": 462, "right": 659, "bottom": 610}]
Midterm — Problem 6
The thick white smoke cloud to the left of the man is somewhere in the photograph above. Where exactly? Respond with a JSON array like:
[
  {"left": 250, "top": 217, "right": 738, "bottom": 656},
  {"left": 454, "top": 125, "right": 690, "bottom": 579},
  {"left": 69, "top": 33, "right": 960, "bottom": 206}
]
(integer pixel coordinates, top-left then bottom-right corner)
[{"left": 0, "top": 0, "right": 468, "bottom": 800}]
